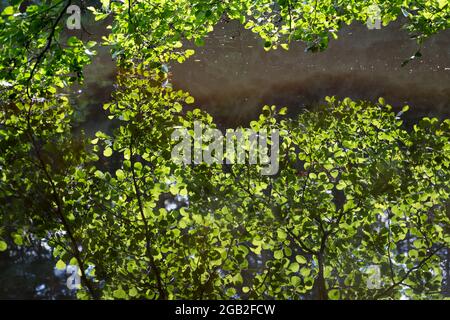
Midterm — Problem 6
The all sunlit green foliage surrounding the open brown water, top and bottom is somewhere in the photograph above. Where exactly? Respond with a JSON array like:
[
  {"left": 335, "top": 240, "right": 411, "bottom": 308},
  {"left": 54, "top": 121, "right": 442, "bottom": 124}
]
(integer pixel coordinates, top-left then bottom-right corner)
[{"left": 0, "top": 0, "right": 450, "bottom": 299}]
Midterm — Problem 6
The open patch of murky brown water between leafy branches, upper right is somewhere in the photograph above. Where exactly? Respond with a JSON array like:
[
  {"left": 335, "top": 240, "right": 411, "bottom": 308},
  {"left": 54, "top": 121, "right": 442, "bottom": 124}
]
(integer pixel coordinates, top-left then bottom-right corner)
[{"left": 171, "top": 21, "right": 450, "bottom": 126}]
